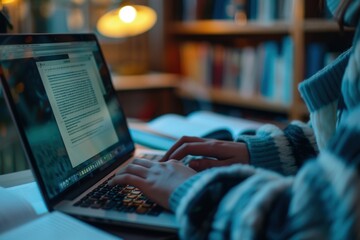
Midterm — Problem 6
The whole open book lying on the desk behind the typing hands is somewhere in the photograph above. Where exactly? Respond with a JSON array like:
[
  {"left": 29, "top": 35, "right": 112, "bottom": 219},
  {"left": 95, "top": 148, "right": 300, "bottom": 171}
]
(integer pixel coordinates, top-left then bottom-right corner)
[{"left": 130, "top": 111, "right": 262, "bottom": 150}]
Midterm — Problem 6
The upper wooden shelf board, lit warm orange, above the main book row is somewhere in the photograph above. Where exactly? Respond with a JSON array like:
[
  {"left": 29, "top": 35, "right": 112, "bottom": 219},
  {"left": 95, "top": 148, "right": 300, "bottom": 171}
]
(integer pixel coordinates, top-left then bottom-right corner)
[{"left": 169, "top": 20, "right": 291, "bottom": 36}]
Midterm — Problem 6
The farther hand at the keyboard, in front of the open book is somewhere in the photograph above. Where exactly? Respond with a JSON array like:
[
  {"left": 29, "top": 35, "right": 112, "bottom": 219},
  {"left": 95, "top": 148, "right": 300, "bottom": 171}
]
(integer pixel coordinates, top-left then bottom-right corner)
[{"left": 160, "top": 137, "right": 250, "bottom": 171}]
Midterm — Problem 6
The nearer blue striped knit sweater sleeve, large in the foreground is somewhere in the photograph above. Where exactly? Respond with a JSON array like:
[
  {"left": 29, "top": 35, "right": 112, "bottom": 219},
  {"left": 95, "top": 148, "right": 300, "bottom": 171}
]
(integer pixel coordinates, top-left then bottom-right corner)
[{"left": 170, "top": 107, "right": 360, "bottom": 239}]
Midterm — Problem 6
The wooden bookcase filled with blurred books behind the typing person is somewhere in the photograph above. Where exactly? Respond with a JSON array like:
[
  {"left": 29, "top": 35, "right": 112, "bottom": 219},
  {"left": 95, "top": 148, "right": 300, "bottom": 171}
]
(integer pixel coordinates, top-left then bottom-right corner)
[{"left": 166, "top": 0, "right": 353, "bottom": 120}]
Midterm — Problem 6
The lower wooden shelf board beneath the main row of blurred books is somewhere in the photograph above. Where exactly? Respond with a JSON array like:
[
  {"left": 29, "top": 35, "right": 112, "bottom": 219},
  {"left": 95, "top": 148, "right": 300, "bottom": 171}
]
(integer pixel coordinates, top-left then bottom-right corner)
[{"left": 178, "top": 82, "right": 290, "bottom": 114}]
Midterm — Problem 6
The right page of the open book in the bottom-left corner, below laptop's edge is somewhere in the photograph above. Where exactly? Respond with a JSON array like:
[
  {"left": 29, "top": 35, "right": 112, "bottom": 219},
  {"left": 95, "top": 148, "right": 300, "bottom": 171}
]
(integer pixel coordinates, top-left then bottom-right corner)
[{"left": 0, "top": 212, "right": 119, "bottom": 240}]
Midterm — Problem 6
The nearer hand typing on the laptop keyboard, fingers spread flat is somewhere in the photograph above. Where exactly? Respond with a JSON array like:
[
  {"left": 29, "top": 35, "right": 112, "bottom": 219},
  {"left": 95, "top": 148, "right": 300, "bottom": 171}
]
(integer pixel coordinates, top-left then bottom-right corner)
[{"left": 109, "top": 159, "right": 196, "bottom": 209}]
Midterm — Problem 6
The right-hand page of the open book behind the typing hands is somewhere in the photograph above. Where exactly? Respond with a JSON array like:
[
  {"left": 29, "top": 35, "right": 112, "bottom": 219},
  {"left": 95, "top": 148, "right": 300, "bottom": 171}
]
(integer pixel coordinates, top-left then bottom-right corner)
[{"left": 187, "top": 111, "right": 262, "bottom": 138}]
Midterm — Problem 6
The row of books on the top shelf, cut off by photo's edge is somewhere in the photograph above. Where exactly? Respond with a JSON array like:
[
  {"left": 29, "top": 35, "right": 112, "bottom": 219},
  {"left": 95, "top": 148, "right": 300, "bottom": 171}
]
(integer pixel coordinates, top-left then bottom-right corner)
[{"left": 177, "top": 0, "right": 294, "bottom": 21}]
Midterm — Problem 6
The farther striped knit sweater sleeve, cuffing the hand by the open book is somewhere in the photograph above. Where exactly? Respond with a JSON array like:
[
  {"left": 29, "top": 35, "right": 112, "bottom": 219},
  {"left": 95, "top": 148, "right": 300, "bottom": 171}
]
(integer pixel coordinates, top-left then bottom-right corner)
[{"left": 237, "top": 121, "right": 318, "bottom": 175}]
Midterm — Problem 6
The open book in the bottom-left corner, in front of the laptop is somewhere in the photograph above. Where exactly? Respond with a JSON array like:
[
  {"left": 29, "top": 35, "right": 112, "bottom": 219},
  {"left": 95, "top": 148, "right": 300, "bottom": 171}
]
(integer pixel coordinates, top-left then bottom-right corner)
[{"left": 0, "top": 188, "right": 119, "bottom": 240}]
